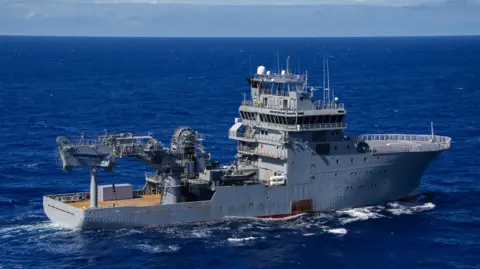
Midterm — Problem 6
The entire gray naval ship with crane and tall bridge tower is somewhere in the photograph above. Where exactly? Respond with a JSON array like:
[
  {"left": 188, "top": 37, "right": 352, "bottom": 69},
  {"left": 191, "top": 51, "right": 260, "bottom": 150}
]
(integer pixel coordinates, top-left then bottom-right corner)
[{"left": 43, "top": 57, "right": 451, "bottom": 229}]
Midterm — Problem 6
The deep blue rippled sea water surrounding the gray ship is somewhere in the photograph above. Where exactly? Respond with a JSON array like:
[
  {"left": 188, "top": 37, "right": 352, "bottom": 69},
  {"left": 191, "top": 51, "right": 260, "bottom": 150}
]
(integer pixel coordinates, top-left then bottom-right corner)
[{"left": 0, "top": 37, "right": 480, "bottom": 268}]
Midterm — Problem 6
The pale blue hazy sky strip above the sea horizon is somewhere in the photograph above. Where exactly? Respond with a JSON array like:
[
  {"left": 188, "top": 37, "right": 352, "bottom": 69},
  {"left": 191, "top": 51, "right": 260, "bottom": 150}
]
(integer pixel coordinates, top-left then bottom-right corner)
[{"left": 0, "top": 0, "right": 480, "bottom": 37}]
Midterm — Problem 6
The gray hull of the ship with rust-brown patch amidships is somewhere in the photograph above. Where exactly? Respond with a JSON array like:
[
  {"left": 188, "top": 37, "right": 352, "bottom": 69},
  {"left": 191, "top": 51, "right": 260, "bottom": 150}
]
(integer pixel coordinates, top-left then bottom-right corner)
[{"left": 43, "top": 151, "right": 440, "bottom": 229}]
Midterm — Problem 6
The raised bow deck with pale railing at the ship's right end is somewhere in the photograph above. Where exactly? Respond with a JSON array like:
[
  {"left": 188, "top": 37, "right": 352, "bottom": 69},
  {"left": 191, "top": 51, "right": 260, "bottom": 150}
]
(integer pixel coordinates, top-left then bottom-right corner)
[{"left": 358, "top": 134, "right": 452, "bottom": 153}]
